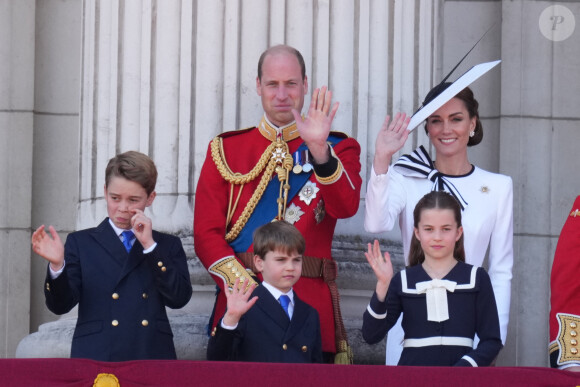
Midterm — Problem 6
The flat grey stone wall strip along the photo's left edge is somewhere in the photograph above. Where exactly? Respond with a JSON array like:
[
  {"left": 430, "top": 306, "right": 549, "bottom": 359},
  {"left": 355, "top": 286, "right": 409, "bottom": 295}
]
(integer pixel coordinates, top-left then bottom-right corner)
[{"left": 0, "top": 0, "right": 35, "bottom": 357}]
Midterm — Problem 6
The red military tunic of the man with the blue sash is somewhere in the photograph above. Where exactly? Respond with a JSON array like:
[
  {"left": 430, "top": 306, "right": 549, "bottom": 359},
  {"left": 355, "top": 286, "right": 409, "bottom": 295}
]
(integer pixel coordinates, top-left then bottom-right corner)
[{"left": 194, "top": 123, "right": 362, "bottom": 353}]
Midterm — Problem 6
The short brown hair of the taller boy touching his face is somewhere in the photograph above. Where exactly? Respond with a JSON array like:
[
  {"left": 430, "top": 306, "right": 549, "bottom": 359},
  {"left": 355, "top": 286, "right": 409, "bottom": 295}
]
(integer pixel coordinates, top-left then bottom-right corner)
[{"left": 105, "top": 151, "right": 157, "bottom": 196}]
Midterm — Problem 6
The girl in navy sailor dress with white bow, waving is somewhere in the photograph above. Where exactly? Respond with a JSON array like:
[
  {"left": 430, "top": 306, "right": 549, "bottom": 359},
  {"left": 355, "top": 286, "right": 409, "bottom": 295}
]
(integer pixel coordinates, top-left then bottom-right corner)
[{"left": 362, "top": 191, "right": 502, "bottom": 367}]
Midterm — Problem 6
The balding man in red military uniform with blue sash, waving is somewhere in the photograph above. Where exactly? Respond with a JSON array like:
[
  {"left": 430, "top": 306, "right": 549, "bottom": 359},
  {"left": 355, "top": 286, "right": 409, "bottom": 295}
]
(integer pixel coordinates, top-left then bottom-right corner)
[{"left": 194, "top": 45, "right": 362, "bottom": 362}]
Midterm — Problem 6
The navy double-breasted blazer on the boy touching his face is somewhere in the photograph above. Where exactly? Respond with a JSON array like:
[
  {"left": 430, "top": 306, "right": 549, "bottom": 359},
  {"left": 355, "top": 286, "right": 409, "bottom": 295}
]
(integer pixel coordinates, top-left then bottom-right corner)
[{"left": 44, "top": 218, "right": 192, "bottom": 361}]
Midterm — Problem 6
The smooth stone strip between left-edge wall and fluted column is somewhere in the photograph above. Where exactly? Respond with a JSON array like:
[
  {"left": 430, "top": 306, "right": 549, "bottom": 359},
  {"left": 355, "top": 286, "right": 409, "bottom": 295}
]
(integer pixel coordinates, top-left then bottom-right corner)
[{"left": 30, "top": 0, "right": 82, "bottom": 342}]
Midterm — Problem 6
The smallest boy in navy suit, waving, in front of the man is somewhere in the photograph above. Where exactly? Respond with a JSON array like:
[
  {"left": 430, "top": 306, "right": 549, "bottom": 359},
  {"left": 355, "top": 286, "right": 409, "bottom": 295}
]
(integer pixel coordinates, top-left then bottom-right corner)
[{"left": 207, "top": 221, "right": 322, "bottom": 363}]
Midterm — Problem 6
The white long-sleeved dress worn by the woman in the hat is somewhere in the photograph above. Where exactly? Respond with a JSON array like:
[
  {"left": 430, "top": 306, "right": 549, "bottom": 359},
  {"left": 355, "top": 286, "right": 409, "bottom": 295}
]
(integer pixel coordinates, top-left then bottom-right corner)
[{"left": 365, "top": 148, "right": 513, "bottom": 365}]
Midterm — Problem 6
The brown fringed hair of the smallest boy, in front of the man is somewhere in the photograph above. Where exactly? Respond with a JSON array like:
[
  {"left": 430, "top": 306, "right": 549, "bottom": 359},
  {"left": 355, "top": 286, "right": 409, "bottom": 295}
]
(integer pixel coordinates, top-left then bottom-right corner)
[{"left": 254, "top": 220, "right": 306, "bottom": 259}]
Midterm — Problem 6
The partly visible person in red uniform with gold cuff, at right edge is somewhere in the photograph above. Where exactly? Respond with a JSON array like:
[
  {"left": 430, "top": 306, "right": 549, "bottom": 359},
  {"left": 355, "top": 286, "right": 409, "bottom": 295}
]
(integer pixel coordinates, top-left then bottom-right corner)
[{"left": 549, "top": 196, "right": 580, "bottom": 371}]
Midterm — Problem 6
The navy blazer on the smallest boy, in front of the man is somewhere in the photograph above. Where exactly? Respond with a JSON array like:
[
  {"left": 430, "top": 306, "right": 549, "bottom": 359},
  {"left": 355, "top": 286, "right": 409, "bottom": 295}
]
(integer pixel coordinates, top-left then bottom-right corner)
[{"left": 207, "top": 286, "right": 322, "bottom": 363}]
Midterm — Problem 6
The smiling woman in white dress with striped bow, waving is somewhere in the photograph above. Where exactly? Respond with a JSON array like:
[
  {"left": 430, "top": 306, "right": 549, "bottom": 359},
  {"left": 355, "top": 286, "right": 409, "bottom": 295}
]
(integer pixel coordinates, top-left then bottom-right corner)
[{"left": 365, "top": 83, "right": 513, "bottom": 365}]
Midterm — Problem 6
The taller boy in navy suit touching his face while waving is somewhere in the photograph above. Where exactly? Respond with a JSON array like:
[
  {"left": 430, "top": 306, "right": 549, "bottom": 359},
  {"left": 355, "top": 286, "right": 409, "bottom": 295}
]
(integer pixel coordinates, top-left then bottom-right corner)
[{"left": 32, "top": 151, "right": 192, "bottom": 361}]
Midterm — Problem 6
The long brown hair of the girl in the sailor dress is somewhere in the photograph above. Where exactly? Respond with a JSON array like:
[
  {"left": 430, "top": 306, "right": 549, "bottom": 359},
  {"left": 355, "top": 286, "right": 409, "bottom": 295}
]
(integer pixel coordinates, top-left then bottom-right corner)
[{"left": 409, "top": 191, "right": 465, "bottom": 266}]
